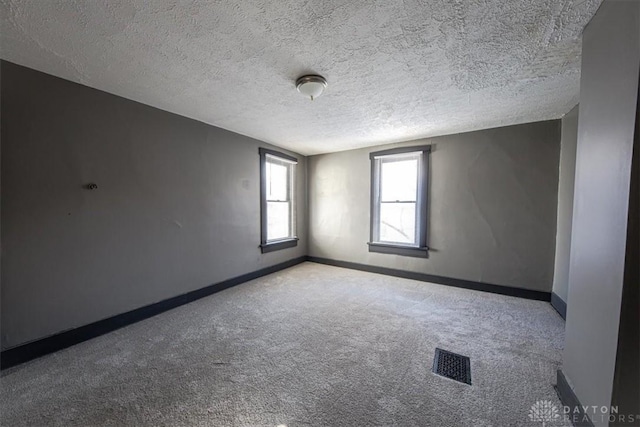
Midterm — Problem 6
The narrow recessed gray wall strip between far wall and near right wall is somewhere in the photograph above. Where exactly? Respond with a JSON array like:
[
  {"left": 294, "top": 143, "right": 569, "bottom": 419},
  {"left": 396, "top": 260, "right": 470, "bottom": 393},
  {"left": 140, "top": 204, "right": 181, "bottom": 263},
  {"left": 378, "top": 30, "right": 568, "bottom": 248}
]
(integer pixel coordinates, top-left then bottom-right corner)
[{"left": 553, "top": 105, "right": 579, "bottom": 302}]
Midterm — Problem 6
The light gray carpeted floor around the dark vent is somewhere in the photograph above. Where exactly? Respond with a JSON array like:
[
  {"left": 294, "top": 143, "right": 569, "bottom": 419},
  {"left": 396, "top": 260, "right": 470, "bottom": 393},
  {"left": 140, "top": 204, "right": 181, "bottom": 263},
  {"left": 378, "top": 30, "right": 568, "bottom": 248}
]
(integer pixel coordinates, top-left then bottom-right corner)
[{"left": 0, "top": 263, "right": 564, "bottom": 427}]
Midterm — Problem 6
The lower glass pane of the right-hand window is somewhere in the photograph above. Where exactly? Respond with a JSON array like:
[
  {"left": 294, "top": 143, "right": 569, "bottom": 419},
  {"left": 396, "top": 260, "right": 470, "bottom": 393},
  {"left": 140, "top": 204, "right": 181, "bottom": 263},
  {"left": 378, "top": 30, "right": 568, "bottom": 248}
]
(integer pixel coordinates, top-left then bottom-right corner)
[{"left": 380, "top": 203, "right": 416, "bottom": 245}]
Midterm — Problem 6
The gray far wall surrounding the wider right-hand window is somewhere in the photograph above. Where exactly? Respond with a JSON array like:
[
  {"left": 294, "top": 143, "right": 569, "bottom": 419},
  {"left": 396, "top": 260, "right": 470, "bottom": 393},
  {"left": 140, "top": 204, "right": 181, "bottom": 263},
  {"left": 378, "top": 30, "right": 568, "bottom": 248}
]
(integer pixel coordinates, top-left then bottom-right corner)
[{"left": 308, "top": 121, "right": 560, "bottom": 291}]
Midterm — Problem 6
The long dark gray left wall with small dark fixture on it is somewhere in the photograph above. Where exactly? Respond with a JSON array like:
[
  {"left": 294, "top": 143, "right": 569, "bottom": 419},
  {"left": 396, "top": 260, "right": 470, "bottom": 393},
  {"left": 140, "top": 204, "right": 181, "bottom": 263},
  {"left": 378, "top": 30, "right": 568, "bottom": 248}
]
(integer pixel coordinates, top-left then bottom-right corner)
[{"left": 1, "top": 62, "right": 307, "bottom": 349}]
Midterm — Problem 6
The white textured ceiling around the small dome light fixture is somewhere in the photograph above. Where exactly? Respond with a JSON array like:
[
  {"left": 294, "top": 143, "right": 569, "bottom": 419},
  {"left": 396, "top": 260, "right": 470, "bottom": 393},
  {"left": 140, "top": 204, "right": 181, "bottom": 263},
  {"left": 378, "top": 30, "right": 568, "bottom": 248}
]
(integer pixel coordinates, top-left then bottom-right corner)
[{"left": 0, "top": 0, "right": 602, "bottom": 154}]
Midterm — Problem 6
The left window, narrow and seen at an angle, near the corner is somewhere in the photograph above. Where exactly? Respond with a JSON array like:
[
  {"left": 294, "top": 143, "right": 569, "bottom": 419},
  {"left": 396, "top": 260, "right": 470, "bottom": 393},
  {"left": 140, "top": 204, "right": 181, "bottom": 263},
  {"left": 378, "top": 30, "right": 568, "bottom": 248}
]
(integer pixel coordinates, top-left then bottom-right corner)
[{"left": 260, "top": 148, "right": 298, "bottom": 253}]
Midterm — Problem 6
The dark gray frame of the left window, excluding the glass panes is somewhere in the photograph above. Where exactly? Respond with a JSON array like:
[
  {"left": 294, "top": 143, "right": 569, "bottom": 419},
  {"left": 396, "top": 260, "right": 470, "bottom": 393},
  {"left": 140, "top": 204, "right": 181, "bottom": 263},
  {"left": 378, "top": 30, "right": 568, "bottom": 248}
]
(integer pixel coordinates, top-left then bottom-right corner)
[{"left": 258, "top": 147, "right": 299, "bottom": 254}]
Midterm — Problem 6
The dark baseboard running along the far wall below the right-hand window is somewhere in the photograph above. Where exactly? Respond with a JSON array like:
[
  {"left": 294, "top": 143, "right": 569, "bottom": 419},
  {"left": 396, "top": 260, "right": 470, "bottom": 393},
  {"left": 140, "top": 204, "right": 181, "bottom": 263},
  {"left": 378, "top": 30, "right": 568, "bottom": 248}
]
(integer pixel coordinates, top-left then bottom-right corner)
[{"left": 307, "top": 256, "right": 551, "bottom": 302}]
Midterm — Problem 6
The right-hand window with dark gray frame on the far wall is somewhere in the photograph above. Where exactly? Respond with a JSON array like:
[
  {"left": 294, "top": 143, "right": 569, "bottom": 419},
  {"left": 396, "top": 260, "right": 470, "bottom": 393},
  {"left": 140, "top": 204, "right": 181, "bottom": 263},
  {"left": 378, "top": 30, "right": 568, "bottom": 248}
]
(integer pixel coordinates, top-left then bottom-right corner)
[{"left": 369, "top": 146, "right": 431, "bottom": 257}]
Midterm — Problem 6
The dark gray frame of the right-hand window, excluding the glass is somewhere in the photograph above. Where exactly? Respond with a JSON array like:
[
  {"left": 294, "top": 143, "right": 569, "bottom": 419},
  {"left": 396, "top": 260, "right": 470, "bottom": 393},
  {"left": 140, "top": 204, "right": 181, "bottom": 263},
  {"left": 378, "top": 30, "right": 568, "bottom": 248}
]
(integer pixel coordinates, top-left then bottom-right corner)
[{"left": 367, "top": 145, "right": 431, "bottom": 258}]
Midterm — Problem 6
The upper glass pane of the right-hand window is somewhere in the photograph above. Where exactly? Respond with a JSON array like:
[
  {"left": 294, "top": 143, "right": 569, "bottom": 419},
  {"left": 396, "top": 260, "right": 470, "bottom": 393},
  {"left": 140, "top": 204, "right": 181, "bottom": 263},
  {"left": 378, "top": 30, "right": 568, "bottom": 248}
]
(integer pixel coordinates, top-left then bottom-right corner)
[{"left": 380, "top": 158, "right": 418, "bottom": 202}]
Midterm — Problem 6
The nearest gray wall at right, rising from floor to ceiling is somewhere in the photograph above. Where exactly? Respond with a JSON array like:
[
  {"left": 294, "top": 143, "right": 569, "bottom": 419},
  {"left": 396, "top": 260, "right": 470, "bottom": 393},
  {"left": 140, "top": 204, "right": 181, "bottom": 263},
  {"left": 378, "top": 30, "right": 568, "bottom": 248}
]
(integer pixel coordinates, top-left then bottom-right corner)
[{"left": 563, "top": 0, "right": 640, "bottom": 425}]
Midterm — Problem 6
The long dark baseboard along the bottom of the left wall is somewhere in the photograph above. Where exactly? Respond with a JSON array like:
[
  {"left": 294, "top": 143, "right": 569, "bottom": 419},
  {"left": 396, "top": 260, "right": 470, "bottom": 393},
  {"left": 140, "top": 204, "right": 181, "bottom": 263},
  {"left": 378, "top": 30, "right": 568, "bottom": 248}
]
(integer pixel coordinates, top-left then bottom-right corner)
[{"left": 0, "top": 256, "right": 307, "bottom": 369}]
